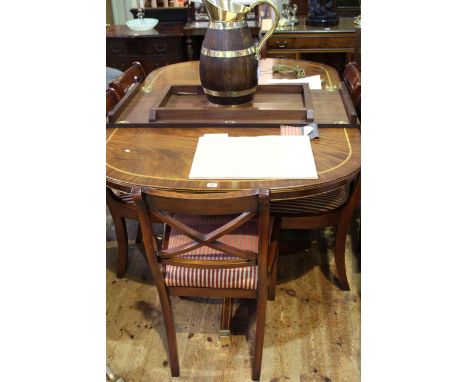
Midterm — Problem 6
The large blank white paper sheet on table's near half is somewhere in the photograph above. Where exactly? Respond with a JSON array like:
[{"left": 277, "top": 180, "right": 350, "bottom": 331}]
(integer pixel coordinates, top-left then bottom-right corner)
[{"left": 189, "top": 135, "right": 318, "bottom": 179}]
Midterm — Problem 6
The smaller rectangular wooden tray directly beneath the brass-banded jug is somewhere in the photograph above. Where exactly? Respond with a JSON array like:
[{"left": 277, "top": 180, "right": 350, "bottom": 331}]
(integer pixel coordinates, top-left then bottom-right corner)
[{"left": 149, "top": 84, "right": 314, "bottom": 127}]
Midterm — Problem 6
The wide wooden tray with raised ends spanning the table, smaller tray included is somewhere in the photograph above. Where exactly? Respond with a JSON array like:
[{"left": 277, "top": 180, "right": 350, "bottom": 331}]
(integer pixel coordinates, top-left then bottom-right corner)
[{"left": 107, "top": 83, "right": 359, "bottom": 128}]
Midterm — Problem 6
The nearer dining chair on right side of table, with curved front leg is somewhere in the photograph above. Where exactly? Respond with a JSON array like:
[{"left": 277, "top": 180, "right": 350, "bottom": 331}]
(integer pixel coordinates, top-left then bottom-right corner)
[{"left": 271, "top": 173, "right": 361, "bottom": 290}]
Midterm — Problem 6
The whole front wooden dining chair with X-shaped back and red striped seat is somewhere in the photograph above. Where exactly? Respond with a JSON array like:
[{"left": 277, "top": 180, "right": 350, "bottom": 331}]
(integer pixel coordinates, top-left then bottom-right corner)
[{"left": 132, "top": 187, "right": 279, "bottom": 381}]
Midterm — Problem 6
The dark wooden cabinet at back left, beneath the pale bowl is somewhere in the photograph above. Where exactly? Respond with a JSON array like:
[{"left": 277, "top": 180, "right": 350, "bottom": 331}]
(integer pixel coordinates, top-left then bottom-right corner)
[{"left": 106, "top": 23, "right": 186, "bottom": 73}]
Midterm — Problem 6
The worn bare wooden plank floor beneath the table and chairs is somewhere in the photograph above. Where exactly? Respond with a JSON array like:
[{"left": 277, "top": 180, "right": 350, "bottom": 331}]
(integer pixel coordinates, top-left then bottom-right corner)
[{"left": 106, "top": 210, "right": 360, "bottom": 382}]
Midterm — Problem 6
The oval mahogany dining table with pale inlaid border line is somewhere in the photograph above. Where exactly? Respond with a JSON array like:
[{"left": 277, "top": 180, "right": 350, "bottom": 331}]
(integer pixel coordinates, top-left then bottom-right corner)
[{"left": 106, "top": 58, "right": 361, "bottom": 202}]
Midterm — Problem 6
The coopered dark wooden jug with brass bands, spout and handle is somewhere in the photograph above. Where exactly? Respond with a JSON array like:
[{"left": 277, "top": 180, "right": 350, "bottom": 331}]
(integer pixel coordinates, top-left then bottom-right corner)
[{"left": 200, "top": 0, "right": 279, "bottom": 105}]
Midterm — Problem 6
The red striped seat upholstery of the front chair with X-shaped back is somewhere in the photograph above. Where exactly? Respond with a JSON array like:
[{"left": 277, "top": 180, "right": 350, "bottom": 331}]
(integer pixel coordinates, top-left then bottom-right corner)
[{"left": 164, "top": 215, "right": 258, "bottom": 289}]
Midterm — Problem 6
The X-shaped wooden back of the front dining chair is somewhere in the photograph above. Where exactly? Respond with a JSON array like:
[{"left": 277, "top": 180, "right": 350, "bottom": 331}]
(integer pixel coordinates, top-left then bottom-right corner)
[{"left": 132, "top": 187, "right": 270, "bottom": 278}]
